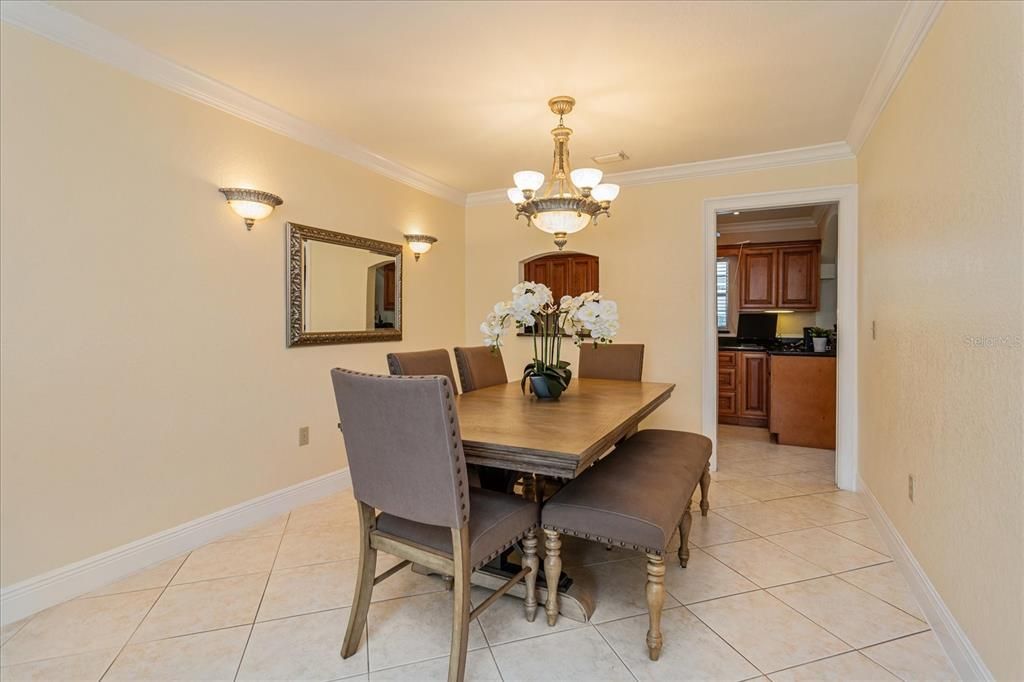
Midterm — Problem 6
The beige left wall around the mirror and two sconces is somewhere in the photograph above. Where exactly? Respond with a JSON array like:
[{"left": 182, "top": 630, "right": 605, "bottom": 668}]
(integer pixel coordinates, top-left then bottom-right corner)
[{"left": 0, "top": 25, "right": 465, "bottom": 586}]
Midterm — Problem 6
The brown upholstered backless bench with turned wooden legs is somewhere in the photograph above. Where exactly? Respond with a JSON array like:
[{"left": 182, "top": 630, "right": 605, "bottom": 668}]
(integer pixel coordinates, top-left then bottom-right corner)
[{"left": 541, "top": 429, "right": 712, "bottom": 660}]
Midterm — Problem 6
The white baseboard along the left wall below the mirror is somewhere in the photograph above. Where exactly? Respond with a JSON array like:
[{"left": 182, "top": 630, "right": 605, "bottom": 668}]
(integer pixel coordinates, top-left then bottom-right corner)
[{"left": 0, "top": 469, "right": 351, "bottom": 625}]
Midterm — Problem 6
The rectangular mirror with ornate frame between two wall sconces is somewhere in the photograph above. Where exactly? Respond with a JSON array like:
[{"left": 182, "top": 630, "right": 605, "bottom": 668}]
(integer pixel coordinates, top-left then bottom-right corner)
[{"left": 285, "top": 222, "right": 401, "bottom": 346}]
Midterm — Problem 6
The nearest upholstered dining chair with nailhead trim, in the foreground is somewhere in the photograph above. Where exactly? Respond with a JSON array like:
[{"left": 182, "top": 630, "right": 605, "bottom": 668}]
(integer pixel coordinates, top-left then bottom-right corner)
[{"left": 331, "top": 369, "right": 540, "bottom": 682}]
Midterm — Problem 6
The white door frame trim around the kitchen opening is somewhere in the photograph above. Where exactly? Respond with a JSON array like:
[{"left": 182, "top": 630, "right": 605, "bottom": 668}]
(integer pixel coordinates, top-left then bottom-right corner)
[{"left": 701, "top": 184, "right": 859, "bottom": 491}]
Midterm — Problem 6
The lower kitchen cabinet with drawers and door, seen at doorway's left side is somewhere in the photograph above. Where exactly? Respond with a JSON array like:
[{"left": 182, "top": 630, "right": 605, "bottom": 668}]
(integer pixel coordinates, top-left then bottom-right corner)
[{"left": 718, "top": 350, "right": 769, "bottom": 426}]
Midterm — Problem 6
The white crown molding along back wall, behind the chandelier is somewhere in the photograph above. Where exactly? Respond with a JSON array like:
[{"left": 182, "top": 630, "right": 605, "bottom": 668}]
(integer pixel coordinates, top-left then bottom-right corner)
[{"left": 466, "top": 141, "right": 854, "bottom": 206}]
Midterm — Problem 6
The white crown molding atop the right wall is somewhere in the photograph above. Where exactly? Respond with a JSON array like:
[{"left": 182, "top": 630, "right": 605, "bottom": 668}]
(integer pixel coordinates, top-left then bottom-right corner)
[{"left": 846, "top": 0, "right": 944, "bottom": 154}]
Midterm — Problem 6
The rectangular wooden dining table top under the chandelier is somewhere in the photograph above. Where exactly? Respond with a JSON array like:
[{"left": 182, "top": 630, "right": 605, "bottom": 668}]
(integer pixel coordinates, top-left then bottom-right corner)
[{"left": 456, "top": 379, "right": 676, "bottom": 478}]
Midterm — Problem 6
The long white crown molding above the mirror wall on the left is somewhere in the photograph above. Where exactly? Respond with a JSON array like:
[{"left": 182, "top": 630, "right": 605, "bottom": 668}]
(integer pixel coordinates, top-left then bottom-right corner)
[{"left": 0, "top": 0, "right": 466, "bottom": 205}]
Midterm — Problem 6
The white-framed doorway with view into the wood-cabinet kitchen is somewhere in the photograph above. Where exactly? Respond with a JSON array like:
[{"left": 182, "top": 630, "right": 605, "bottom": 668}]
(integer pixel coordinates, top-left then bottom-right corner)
[{"left": 702, "top": 185, "right": 857, "bottom": 491}]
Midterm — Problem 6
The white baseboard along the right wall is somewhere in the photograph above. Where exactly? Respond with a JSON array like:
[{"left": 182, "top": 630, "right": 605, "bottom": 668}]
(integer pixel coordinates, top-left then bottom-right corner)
[{"left": 857, "top": 476, "right": 995, "bottom": 680}]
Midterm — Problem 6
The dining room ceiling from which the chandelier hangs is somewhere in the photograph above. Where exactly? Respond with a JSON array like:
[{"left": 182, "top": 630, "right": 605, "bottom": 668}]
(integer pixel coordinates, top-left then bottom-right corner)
[{"left": 51, "top": 0, "right": 905, "bottom": 193}]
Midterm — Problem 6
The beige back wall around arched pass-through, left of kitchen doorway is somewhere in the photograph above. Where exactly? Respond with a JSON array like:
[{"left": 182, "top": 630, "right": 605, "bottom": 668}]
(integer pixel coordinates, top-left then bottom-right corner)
[{"left": 466, "top": 160, "right": 856, "bottom": 431}]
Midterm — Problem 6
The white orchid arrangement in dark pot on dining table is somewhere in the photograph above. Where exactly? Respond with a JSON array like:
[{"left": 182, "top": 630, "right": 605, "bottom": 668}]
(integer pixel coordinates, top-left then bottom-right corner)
[{"left": 480, "top": 282, "right": 618, "bottom": 400}]
